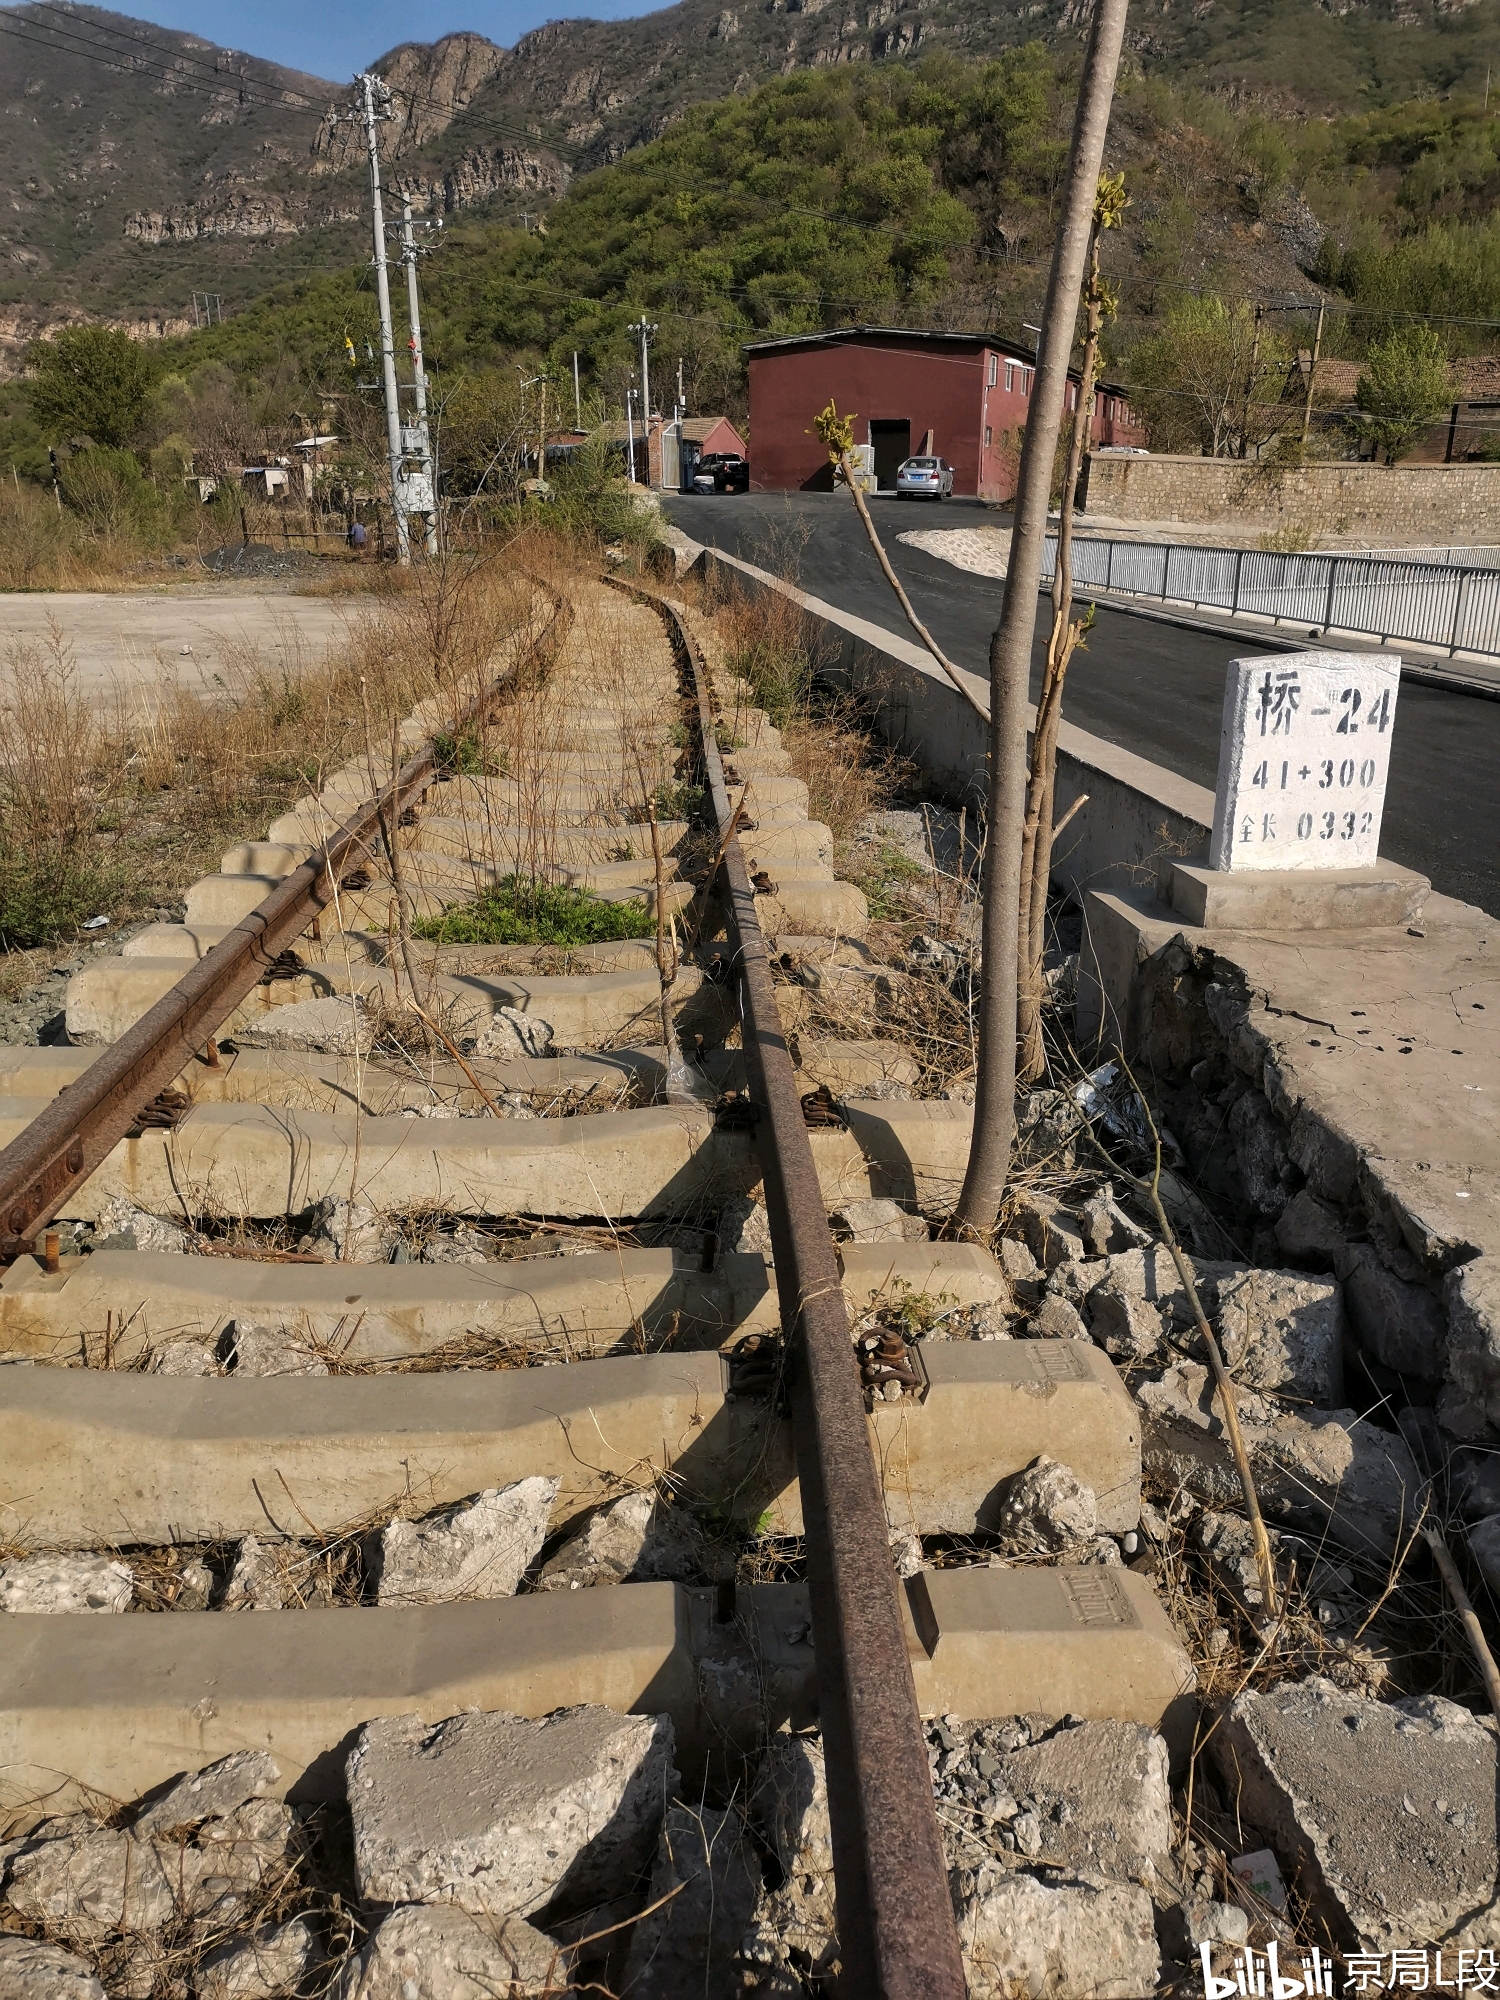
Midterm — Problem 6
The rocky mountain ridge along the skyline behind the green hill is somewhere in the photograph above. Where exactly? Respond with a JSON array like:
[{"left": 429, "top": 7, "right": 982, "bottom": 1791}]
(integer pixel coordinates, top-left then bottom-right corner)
[{"left": 0, "top": 0, "right": 1500, "bottom": 336}]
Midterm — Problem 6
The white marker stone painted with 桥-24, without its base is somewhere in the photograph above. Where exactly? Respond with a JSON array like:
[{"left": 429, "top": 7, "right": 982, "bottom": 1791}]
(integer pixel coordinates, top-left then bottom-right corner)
[{"left": 1208, "top": 652, "right": 1402, "bottom": 872}]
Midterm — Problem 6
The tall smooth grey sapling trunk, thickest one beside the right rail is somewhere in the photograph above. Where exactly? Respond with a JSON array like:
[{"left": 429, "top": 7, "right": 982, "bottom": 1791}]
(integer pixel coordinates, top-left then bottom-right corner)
[{"left": 954, "top": 0, "right": 1128, "bottom": 1236}]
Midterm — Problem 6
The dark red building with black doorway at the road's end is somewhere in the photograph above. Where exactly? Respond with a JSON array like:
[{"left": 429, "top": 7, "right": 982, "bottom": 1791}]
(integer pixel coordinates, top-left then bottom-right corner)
[{"left": 746, "top": 326, "right": 1144, "bottom": 500}]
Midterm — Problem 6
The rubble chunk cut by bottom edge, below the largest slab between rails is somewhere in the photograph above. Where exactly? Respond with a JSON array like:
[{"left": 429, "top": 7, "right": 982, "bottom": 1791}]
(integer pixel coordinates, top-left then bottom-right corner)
[{"left": 328, "top": 1904, "right": 572, "bottom": 2000}]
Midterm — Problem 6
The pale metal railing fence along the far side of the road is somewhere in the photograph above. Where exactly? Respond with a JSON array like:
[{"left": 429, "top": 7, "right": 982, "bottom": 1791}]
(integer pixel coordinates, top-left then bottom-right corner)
[{"left": 1046, "top": 536, "right": 1500, "bottom": 658}]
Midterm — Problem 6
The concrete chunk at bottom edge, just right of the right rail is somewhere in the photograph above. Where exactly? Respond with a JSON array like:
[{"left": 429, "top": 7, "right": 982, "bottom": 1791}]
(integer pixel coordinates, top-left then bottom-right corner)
[{"left": 958, "top": 1868, "right": 1162, "bottom": 2000}]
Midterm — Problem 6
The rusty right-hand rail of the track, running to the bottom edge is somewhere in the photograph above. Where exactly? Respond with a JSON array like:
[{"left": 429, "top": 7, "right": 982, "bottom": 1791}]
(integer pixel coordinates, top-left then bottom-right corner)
[{"left": 620, "top": 580, "right": 966, "bottom": 2000}]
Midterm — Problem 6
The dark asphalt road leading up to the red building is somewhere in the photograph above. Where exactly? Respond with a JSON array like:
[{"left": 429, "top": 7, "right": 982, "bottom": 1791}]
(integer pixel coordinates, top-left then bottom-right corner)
[{"left": 668, "top": 494, "right": 1500, "bottom": 916}]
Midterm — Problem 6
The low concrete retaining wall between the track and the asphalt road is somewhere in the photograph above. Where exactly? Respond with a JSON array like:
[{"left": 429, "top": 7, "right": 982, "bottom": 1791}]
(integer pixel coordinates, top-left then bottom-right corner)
[{"left": 680, "top": 538, "right": 1214, "bottom": 896}]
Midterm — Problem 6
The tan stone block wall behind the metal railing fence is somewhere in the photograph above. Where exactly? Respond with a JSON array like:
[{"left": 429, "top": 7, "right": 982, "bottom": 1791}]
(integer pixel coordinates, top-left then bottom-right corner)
[{"left": 1086, "top": 454, "right": 1500, "bottom": 546}]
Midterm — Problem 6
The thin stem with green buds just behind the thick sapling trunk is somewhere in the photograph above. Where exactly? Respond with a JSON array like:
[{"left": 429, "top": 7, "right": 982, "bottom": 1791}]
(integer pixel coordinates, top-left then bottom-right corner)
[{"left": 1016, "top": 174, "right": 1128, "bottom": 1086}]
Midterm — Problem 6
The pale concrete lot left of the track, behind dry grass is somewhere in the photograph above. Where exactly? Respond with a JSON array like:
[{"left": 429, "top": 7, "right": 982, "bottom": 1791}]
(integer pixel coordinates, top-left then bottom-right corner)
[{"left": 0, "top": 590, "right": 374, "bottom": 700}]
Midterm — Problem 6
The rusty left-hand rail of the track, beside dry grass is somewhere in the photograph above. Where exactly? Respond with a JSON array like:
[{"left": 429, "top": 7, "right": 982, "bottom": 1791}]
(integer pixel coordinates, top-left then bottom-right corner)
[{"left": 0, "top": 594, "right": 572, "bottom": 1260}]
